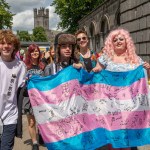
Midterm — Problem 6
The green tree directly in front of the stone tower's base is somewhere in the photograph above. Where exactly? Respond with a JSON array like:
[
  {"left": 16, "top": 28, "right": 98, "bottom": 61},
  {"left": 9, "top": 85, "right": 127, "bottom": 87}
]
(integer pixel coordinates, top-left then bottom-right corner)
[{"left": 33, "top": 27, "right": 48, "bottom": 42}]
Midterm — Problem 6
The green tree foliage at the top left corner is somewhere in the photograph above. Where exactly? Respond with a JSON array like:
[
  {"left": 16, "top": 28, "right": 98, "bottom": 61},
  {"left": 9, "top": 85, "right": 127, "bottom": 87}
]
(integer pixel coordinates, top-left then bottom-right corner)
[{"left": 0, "top": 0, "right": 14, "bottom": 29}]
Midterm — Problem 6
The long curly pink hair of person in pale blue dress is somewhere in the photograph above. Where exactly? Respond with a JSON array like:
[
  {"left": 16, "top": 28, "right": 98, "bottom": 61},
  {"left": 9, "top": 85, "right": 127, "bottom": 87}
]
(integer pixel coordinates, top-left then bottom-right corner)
[{"left": 103, "top": 28, "right": 139, "bottom": 64}]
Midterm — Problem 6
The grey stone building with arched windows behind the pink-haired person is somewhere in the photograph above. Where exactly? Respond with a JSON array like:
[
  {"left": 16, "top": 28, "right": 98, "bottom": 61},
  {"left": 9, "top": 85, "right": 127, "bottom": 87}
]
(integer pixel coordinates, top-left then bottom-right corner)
[{"left": 79, "top": 0, "right": 150, "bottom": 62}]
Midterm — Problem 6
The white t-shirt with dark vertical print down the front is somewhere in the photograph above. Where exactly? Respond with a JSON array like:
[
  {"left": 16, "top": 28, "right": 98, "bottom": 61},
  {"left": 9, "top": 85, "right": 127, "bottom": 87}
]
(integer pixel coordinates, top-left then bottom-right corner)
[{"left": 0, "top": 57, "right": 26, "bottom": 125}]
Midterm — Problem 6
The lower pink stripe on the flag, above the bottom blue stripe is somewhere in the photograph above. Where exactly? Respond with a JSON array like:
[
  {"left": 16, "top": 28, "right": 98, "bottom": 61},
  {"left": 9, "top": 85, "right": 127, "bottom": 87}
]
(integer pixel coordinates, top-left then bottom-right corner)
[{"left": 38, "top": 111, "right": 150, "bottom": 143}]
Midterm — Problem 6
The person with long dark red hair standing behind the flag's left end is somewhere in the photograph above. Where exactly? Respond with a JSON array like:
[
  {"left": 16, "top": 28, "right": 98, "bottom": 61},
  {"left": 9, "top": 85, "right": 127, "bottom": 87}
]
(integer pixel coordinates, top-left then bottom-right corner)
[{"left": 23, "top": 44, "right": 46, "bottom": 150}]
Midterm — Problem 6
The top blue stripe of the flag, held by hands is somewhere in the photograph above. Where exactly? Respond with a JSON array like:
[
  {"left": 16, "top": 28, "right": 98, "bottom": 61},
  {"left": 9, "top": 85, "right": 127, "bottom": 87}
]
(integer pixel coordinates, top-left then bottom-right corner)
[{"left": 28, "top": 66, "right": 145, "bottom": 91}]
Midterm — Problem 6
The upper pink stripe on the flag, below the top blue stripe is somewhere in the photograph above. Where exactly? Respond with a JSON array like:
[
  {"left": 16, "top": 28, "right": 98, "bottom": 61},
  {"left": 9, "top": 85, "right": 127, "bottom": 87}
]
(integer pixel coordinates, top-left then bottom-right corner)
[{"left": 29, "top": 78, "right": 148, "bottom": 106}]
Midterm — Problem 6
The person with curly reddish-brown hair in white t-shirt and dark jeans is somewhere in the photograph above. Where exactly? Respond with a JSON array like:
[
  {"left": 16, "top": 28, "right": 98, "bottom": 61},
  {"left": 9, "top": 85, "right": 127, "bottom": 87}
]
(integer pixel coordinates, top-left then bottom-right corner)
[{"left": 0, "top": 30, "right": 26, "bottom": 150}]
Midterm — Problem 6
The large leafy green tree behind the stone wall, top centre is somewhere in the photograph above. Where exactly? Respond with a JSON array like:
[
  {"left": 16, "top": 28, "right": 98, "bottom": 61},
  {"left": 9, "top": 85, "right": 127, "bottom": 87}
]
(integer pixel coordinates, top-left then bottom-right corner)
[{"left": 51, "top": 0, "right": 104, "bottom": 33}]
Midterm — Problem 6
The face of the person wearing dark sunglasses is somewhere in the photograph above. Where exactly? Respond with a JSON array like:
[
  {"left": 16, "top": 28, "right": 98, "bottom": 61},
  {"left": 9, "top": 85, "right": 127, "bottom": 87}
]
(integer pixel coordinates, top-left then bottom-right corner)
[{"left": 76, "top": 33, "right": 88, "bottom": 48}]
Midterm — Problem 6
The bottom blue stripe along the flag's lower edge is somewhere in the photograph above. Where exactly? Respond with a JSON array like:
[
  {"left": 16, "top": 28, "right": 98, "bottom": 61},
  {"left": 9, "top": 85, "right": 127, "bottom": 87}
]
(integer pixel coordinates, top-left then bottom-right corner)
[{"left": 46, "top": 128, "right": 150, "bottom": 150}]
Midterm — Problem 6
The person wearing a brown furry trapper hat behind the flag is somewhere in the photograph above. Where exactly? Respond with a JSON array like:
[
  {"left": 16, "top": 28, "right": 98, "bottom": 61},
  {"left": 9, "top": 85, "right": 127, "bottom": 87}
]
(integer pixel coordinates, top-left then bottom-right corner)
[{"left": 43, "top": 33, "right": 76, "bottom": 75}]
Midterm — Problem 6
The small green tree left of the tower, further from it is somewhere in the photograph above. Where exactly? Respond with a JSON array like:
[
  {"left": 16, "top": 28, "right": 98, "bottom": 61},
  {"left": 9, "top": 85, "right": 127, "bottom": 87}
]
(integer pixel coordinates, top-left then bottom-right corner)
[{"left": 17, "top": 31, "right": 32, "bottom": 42}]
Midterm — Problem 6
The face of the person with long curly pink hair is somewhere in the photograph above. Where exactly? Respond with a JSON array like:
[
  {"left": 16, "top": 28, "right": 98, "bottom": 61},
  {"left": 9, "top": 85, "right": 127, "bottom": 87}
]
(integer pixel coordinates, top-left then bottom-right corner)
[{"left": 113, "top": 34, "right": 126, "bottom": 54}]
